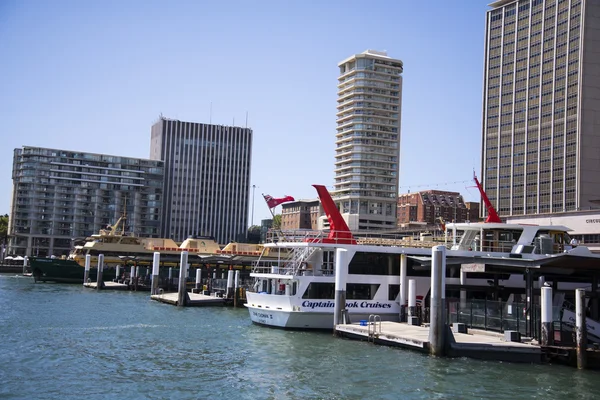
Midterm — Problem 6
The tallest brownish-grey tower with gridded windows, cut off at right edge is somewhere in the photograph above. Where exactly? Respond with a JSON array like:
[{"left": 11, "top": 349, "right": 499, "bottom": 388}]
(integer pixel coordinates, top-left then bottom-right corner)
[{"left": 482, "top": 0, "right": 600, "bottom": 216}]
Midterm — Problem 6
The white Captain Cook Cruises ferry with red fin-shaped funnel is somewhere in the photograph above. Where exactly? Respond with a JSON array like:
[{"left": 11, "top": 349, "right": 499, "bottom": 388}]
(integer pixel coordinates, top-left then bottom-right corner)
[{"left": 246, "top": 185, "right": 600, "bottom": 329}]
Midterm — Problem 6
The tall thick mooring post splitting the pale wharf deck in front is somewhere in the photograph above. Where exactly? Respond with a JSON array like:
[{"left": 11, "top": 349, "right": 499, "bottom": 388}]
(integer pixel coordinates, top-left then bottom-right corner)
[{"left": 429, "top": 246, "right": 446, "bottom": 356}]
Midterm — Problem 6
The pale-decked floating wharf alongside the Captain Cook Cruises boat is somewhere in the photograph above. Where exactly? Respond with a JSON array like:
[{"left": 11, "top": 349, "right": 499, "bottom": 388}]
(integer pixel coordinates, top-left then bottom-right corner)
[{"left": 335, "top": 321, "right": 543, "bottom": 363}]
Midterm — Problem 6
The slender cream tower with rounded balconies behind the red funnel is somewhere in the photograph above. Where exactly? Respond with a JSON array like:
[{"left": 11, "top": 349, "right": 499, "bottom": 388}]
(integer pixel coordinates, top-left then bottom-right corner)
[{"left": 333, "top": 50, "right": 403, "bottom": 230}]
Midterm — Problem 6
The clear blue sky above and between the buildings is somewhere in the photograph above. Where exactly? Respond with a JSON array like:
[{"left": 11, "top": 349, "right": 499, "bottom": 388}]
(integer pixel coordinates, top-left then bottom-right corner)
[{"left": 0, "top": 0, "right": 489, "bottom": 224}]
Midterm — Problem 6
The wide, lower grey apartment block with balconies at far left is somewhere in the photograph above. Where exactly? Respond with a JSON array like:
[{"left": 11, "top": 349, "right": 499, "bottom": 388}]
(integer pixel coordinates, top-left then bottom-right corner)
[{"left": 8, "top": 146, "right": 163, "bottom": 257}]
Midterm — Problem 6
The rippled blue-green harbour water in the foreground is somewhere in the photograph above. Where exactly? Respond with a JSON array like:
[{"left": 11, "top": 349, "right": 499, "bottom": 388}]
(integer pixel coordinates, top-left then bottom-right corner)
[{"left": 0, "top": 274, "right": 600, "bottom": 400}]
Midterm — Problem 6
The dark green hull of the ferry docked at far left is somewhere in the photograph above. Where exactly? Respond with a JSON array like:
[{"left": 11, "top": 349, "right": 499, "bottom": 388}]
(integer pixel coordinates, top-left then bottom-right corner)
[{"left": 29, "top": 257, "right": 115, "bottom": 283}]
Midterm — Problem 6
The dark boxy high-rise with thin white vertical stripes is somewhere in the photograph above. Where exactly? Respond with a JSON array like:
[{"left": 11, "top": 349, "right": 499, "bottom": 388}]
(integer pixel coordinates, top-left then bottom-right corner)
[{"left": 150, "top": 116, "right": 252, "bottom": 244}]
